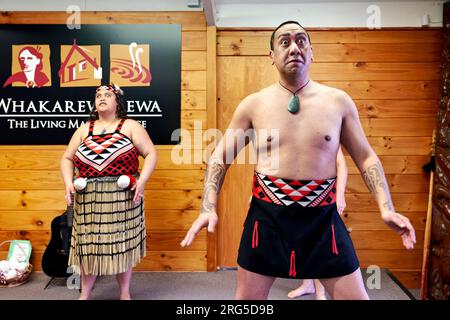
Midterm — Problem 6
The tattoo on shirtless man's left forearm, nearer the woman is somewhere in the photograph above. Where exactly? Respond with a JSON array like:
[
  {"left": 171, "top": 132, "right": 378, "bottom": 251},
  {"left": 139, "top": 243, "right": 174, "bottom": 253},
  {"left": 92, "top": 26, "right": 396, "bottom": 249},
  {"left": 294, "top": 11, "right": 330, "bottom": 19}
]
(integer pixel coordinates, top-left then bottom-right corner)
[{"left": 200, "top": 161, "right": 226, "bottom": 213}]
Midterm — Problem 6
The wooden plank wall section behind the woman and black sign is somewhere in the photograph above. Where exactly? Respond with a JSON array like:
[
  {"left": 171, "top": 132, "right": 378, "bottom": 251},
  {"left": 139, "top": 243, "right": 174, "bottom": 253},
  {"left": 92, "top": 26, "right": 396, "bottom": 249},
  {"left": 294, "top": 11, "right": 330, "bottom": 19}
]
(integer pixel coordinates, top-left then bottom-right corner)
[{"left": 0, "top": 12, "right": 207, "bottom": 271}]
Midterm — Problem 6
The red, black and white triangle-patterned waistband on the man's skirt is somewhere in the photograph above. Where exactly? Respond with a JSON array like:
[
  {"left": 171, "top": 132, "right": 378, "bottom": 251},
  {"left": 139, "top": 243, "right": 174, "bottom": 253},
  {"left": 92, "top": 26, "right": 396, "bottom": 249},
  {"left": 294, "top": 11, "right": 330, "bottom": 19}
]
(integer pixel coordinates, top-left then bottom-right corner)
[{"left": 253, "top": 171, "right": 336, "bottom": 207}]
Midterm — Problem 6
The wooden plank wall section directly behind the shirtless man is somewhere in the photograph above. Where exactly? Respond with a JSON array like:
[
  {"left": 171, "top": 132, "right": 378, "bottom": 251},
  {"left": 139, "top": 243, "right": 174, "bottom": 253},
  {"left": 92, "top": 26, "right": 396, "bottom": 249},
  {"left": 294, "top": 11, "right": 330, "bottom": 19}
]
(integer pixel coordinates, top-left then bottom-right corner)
[{"left": 217, "top": 29, "right": 441, "bottom": 288}]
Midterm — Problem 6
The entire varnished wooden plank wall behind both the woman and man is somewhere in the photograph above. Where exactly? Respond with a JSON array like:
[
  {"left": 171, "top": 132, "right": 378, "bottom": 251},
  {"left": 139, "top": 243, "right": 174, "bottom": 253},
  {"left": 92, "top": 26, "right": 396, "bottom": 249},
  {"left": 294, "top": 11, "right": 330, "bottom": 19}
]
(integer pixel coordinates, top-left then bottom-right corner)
[{"left": 0, "top": 12, "right": 441, "bottom": 288}]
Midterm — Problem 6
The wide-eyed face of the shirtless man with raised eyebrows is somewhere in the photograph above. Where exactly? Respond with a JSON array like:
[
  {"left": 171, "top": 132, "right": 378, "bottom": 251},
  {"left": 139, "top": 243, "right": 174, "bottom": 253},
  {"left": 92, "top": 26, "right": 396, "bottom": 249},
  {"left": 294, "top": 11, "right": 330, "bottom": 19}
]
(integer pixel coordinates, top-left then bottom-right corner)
[{"left": 270, "top": 24, "right": 312, "bottom": 74}]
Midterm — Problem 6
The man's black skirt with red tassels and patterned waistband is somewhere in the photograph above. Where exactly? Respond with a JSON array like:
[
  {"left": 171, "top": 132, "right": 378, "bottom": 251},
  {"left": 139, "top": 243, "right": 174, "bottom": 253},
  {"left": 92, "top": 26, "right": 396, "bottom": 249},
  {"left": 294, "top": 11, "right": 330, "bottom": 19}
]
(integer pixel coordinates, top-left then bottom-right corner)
[{"left": 237, "top": 172, "right": 359, "bottom": 279}]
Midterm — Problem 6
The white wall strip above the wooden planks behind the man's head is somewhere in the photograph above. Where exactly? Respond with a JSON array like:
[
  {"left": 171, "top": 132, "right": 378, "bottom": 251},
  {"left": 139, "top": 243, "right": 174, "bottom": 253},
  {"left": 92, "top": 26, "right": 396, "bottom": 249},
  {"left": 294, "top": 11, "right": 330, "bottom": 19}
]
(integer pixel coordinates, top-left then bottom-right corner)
[{"left": 214, "top": 0, "right": 444, "bottom": 28}]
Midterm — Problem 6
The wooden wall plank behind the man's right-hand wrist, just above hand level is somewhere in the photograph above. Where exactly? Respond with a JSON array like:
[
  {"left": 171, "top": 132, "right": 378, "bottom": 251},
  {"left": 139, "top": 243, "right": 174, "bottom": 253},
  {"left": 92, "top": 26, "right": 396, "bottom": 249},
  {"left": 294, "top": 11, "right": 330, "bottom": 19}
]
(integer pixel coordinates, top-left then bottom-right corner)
[{"left": 345, "top": 193, "right": 428, "bottom": 212}]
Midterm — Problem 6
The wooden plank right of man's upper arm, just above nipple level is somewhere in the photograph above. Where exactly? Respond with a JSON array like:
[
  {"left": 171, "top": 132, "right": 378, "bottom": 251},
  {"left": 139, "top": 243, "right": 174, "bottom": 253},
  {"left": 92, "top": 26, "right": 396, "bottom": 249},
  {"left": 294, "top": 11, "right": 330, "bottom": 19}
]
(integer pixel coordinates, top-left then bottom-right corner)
[{"left": 361, "top": 117, "right": 436, "bottom": 139}]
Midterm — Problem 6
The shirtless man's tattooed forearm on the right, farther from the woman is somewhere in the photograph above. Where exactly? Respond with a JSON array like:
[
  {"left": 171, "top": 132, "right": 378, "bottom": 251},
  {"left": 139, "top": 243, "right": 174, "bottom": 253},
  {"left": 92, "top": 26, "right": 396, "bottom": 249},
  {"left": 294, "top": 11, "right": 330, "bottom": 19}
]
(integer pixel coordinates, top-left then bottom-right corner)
[{"left": 363, "top": 162, "right": 394, "bottom": 212}]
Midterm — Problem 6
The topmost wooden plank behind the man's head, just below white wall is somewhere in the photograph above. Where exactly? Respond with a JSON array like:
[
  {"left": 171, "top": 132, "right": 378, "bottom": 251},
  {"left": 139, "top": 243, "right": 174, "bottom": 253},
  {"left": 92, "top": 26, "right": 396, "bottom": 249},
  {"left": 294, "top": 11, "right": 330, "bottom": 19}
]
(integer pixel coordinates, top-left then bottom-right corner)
[{"left": 217, "top": 28, "right": 442, "bottom": 44}]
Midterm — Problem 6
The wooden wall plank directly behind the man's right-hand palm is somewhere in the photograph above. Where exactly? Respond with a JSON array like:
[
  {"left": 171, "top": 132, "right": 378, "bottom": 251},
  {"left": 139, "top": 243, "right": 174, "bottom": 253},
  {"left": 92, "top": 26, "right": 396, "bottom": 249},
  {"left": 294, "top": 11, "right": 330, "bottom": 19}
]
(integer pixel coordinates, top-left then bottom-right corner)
[{"left": 341, "top": 210, "right": 426, "bottom": 232}]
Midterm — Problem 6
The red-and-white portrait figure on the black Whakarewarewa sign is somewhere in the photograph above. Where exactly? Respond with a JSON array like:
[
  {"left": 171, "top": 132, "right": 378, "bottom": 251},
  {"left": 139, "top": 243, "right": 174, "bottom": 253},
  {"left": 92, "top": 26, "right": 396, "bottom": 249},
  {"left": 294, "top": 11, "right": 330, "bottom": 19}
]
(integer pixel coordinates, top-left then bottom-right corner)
[{"left": 3, "top": 46, "right": 49, "bottom": 88}]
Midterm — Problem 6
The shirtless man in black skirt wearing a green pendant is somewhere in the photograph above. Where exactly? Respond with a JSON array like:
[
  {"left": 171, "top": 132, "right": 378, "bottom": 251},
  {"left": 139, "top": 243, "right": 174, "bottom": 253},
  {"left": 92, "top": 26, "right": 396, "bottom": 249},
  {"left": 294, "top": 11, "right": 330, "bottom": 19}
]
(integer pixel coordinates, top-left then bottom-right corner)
[{"left": 181, "top": 21, "right": 416, "bottom": 299}]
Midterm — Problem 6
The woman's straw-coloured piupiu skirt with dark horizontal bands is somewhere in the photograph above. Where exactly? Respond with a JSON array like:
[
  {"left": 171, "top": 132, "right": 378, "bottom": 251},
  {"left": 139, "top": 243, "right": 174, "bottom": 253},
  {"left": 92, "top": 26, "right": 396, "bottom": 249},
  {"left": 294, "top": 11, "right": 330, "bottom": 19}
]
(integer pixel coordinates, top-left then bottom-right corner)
[{"left": 69, "top": 177, "right": 146, "bottom": 276}]
